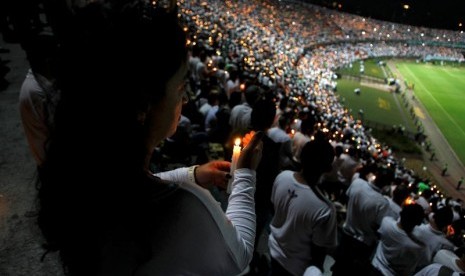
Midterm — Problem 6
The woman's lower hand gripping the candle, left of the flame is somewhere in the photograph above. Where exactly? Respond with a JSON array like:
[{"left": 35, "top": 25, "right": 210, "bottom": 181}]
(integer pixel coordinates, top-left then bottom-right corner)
[{"left": 194, "top": 161, "right": 231, "bottom": 189}]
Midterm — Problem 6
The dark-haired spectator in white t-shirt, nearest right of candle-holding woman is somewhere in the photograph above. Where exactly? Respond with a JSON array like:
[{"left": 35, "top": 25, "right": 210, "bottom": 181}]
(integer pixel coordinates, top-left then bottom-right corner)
[{"left": 268, "top": 135, "right": 337, "bottom": 276}]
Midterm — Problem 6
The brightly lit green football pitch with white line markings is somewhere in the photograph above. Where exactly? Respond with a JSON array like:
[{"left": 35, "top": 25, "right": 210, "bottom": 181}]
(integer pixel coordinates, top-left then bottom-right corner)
[{"left": 396, "top": 62, "right": 465, "bottom": 164}]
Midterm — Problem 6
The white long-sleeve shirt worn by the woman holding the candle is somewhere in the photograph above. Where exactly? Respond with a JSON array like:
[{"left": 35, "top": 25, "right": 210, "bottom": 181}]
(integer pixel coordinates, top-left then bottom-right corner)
[{"left": 136, "top": 168, "right": 255, "bottom": 275}]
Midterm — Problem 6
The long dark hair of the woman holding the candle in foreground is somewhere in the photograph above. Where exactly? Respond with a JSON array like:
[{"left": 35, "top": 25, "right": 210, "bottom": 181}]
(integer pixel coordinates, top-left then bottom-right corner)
[{"left": 38, "top": 1, "right": 187, "bottom": 275}]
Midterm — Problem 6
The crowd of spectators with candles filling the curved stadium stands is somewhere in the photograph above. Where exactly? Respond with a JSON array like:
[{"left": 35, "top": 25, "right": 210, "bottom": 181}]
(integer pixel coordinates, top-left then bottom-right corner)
[{"left": 9, "top": 0, "right": 465, "bottom": 275}]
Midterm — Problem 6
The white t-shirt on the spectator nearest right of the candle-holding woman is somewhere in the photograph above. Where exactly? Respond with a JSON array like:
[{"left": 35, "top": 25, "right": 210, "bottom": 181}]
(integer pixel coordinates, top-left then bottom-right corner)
[{"left": 268, "top": 171, "right": 337, "bottom": 275}]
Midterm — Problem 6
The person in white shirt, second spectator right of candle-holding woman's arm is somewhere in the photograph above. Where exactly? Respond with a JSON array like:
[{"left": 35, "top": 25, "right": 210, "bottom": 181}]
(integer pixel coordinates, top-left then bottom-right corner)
[{"left": 332, "top": 164, "right": 394, "bottom": 275}]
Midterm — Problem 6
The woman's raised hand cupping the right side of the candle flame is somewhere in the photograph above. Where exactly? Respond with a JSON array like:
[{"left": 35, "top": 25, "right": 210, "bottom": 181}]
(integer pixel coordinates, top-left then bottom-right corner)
[{"left": 237, "top": 131, "right": 265, "bottom": 170}]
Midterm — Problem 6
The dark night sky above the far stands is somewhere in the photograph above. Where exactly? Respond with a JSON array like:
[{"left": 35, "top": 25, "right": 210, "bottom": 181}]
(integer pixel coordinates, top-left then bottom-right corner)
[{"left": 305, "top": 0, "right": 465, "bottom": 30}]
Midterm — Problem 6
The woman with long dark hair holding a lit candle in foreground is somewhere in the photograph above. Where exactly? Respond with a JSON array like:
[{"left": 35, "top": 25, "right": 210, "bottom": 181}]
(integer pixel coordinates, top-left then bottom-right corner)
[{"left": 39, "top": 1, "right": 262, "bottom": 276}]
